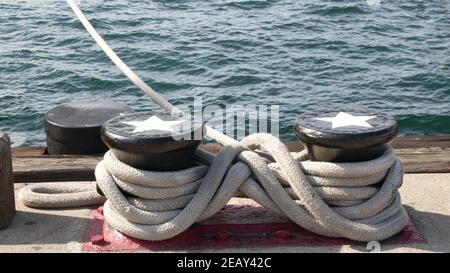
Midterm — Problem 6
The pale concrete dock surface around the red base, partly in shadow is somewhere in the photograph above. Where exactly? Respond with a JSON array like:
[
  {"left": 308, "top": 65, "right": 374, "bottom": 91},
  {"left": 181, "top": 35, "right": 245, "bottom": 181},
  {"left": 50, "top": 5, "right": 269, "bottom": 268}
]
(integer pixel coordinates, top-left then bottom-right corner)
[{"left": 0, "top": 173, "right": 450, "bottom": 253}]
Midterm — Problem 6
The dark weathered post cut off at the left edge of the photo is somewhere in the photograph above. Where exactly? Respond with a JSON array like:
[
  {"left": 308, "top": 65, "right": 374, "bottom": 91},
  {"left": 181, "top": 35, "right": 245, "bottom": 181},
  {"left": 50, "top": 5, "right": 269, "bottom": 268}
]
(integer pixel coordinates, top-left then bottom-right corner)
[{"left": 0, "top": 132, "right": 16, "bottom": 229}]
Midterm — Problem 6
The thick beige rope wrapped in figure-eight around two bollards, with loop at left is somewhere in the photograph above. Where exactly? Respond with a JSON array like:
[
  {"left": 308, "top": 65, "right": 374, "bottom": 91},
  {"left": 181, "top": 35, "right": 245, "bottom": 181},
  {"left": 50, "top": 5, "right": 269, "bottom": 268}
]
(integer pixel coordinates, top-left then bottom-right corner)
[{"left": 21, "top": 134, "right": 409, "bottom": 241}]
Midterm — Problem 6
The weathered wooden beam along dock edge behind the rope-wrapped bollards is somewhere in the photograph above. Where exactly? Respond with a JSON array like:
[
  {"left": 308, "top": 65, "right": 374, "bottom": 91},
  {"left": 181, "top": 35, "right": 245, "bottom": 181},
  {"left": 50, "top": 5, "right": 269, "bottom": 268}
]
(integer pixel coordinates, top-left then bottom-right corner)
[{"left": 9, "top": 136, "right": 450, "bottom": 183}]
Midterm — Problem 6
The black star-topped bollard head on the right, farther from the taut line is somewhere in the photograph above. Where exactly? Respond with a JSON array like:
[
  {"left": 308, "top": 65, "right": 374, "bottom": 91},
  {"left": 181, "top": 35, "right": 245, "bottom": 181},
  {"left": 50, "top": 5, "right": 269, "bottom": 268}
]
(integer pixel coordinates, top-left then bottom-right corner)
[{"left": 294, "top": 109, "right": 398, "bottom": 162}]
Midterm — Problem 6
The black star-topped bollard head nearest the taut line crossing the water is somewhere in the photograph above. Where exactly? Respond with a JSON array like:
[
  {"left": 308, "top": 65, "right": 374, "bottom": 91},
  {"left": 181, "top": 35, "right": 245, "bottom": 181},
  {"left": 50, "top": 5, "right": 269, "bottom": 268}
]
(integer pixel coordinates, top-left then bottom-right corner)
[{"left": 102, "top": 110, "right": 204, "bottom": 171}]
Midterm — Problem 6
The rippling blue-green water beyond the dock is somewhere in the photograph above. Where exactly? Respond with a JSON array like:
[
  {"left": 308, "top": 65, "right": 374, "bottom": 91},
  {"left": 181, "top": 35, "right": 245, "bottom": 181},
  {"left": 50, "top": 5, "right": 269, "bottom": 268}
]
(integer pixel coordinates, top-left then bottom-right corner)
[{"left": 0, "top": 0, "right": 450, "bottom": 146}]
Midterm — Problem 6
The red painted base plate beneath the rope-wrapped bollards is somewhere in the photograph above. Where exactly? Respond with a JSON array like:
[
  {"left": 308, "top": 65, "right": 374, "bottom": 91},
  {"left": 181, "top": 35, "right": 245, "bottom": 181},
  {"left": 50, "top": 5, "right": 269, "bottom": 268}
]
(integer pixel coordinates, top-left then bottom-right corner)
[{"left": 83, "top": 205, "right": 425, "bottom": 251}]
